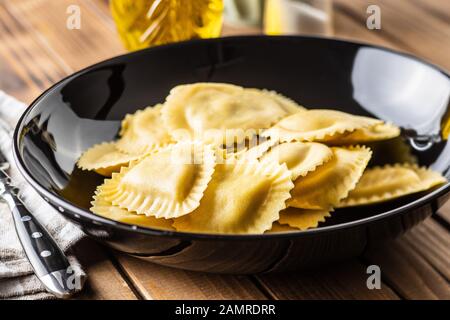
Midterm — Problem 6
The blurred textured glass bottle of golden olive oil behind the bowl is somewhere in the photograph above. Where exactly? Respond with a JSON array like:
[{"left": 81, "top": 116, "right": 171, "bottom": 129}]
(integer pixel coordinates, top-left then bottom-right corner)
[{"left": 110, "top": 0, "right": 223, "bottom": 50}]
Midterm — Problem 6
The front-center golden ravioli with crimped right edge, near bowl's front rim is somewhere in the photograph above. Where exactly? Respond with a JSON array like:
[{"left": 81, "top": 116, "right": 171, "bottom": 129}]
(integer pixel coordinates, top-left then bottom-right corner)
[{"left": 173, "top": 161, "right": 293, "bottom": 233}]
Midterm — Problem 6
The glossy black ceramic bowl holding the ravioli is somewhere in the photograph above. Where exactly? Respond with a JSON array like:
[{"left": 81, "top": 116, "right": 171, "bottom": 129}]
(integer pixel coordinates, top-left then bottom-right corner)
[{"left": 14, "top": 36, "right": 450, "bottom": 273}]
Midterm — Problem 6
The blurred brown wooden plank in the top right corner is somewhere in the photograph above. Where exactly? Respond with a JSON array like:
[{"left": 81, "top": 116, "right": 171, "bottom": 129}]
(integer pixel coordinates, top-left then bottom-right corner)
[{"left": 335, "top": 0, "right": 450, "bottom": 70}]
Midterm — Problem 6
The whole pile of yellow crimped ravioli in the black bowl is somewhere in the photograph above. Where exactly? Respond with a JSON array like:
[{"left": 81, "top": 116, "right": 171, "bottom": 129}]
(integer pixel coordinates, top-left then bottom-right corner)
[{"left": 77, "top": 83, "right": 447, "bottom": 234}]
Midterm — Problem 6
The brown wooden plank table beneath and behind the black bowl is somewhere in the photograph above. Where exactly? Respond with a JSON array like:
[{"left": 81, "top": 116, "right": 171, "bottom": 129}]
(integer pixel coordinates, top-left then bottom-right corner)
[{"left": 0, "top": 0, "right": 450, "bottom": 299}]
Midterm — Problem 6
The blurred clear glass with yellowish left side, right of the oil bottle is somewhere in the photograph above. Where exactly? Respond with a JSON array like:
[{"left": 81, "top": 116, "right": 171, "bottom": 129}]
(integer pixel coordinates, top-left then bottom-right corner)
[{"left": 264, "top": 0, "right": 333, "bottom": 36}]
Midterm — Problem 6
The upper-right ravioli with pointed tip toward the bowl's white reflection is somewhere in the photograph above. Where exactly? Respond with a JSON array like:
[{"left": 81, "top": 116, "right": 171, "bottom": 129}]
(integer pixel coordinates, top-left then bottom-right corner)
[{"left": 262, "top": 109, "right": 383, "bottom": 142}]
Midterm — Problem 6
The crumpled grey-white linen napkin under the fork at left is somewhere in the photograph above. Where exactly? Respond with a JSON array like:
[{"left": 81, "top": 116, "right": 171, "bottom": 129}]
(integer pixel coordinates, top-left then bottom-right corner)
[{"left": 0, "top": 91, "right": 85, "bottom": 300}]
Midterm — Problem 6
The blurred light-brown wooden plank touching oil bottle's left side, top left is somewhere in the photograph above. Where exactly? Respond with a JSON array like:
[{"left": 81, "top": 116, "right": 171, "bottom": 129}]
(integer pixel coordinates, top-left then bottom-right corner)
[{"left": 5, "top": 0, "right": 124, "bottom": 70}]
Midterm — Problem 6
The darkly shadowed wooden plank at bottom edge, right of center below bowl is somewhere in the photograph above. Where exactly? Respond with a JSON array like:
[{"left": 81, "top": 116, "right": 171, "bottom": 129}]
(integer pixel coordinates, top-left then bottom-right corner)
[{"left": 258, "top": 260, "right": 399, "bottom": 300}]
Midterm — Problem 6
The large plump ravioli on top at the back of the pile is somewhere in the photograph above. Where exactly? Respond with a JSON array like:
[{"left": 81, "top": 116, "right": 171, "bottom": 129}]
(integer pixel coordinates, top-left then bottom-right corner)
[{"left": 162, "top": 83, "right": 301, "bottom": 145}]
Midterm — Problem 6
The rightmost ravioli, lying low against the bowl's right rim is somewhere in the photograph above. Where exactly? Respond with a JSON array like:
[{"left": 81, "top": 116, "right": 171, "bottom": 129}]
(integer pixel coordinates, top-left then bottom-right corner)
[{"left": 338, "top": 164, "right": 447, "bottom": 207}]
